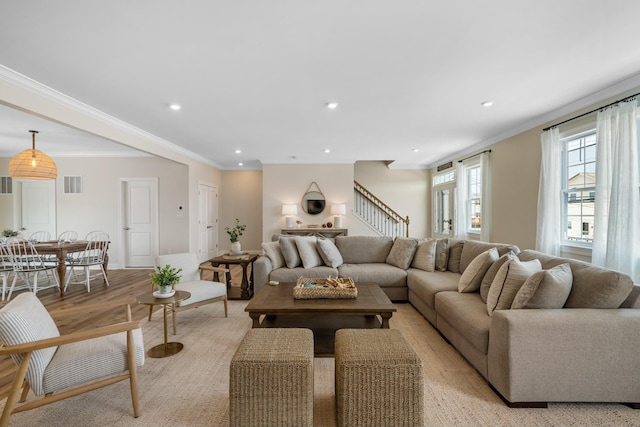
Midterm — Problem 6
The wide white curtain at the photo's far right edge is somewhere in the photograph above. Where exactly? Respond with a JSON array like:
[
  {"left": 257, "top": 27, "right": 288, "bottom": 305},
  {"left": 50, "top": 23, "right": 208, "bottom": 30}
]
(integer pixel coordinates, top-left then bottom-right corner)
[{"left": 592, "top": 99, "right": 640, "bottom": 282}]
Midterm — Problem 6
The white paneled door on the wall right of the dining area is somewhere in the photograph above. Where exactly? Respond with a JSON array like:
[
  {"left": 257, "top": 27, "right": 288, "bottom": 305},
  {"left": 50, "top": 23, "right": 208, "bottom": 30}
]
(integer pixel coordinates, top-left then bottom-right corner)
[{"left": 122, "top": 178, "right": 159, "bottom": 267}]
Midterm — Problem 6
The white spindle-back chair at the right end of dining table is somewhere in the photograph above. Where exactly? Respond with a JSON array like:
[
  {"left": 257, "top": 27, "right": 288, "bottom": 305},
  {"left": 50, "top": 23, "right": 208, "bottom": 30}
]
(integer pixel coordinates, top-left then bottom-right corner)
[{"left": 64, "top": 231, "right": 109, "bottom": 292}]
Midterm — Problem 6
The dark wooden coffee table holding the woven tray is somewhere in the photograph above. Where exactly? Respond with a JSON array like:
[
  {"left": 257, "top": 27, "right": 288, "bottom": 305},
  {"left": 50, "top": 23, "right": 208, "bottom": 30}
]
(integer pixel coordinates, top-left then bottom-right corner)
[{"left": 245, "top": 283, "right": 396, "bottom": 357}]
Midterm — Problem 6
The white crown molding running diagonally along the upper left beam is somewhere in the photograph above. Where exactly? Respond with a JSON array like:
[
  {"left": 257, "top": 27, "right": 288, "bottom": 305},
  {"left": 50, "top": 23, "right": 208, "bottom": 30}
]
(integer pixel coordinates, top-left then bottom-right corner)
[{"left": 0, "top": 64, "right": 222, "bottom": 169}]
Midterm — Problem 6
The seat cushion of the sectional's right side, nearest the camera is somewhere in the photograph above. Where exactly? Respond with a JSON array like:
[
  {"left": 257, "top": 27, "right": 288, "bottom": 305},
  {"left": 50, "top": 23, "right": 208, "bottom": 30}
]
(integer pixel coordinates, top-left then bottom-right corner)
[{"left": 435, "top": 291, "right": 491, "bottom": 354}]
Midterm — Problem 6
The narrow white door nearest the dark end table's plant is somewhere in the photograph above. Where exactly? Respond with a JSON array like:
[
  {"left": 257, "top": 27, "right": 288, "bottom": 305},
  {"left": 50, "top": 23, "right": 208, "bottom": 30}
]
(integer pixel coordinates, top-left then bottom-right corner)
[{"left": 198, "top": 184, "right": 218, "bottom": 261}]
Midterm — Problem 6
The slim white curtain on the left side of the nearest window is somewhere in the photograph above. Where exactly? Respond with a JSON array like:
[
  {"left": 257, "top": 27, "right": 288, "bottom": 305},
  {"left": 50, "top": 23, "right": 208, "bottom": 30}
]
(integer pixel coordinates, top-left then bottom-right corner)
[{"left": 536, "top": 128, "right": 562, "bottom": 256}]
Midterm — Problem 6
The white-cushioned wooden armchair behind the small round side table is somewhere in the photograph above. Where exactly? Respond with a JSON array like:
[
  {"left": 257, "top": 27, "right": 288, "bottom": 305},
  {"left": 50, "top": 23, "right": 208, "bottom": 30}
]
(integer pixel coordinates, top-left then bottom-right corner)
[{"left": 149, "top": 253, "right": 228, "bottom": 335}]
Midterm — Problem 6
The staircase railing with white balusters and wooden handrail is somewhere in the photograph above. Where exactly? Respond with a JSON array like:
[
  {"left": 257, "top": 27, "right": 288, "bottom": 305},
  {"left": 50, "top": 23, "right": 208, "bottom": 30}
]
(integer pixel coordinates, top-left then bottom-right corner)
[{"left": 353, "top": 181, "right": 409, "bottom": 237}]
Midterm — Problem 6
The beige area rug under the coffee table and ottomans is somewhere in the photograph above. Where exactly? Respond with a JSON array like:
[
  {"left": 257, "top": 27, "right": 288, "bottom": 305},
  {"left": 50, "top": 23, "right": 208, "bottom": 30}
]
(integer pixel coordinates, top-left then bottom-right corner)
[{"left": 0, "top": 301, "right": 640, "bottom": 427}]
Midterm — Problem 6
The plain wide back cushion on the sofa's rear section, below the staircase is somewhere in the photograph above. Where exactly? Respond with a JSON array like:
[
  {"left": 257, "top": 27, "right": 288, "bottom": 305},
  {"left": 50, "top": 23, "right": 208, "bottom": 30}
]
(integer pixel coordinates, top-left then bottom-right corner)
[{"left": 336, "top": 236, "right": 393, "bottom": 264}]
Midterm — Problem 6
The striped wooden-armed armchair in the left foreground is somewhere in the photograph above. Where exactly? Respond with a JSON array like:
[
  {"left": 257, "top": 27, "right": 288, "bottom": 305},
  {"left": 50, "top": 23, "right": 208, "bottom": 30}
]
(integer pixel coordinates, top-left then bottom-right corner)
[{"left": 0, "top": 292, "right": 144, "bottom": 427}]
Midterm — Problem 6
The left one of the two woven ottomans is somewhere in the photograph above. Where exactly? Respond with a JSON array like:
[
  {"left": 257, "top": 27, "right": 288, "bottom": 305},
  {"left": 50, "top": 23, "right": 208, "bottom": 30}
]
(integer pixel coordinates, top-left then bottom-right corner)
[{"left": 229, "top": 328, "right": 313, "bottom": 427}]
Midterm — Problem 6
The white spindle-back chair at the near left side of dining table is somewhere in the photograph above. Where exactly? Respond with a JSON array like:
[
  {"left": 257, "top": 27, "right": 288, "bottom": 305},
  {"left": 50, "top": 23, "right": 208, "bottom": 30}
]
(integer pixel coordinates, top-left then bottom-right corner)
[{"left": 5, "top": 237, "right": 60, "bottom": 299}]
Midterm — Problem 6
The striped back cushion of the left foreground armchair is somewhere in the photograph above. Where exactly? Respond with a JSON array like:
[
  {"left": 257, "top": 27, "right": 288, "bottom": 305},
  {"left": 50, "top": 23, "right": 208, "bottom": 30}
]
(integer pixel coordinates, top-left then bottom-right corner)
[{"left": 0, "top": 292, "right": 60, "bottom": 396}]
